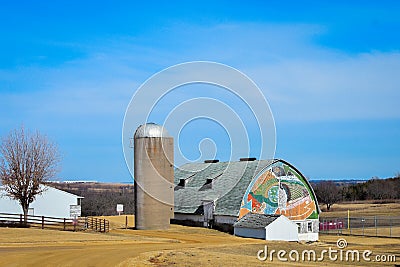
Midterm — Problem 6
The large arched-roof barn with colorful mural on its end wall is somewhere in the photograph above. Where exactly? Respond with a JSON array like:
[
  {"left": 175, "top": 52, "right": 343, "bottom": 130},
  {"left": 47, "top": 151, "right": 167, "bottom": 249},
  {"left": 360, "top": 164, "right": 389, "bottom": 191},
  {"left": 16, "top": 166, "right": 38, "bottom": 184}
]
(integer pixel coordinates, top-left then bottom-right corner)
[{"left": 174, "top": 158, "right": 320, "bottom": 241}]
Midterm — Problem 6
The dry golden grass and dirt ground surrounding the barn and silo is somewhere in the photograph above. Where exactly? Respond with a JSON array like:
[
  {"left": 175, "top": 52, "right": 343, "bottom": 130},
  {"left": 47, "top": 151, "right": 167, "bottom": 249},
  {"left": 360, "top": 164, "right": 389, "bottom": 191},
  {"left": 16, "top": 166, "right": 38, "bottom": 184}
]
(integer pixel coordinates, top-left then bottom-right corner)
[{"left": 0, "top": 204, "right": 400, "bottom": 267}]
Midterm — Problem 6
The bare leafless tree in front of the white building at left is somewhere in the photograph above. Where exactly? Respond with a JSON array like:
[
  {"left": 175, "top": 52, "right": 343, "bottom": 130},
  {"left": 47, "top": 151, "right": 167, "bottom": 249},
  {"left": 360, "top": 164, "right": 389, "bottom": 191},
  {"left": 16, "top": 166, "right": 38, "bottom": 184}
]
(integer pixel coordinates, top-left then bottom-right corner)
[{"left": 0, "top": 127, "right": 60, "bottom": 223}]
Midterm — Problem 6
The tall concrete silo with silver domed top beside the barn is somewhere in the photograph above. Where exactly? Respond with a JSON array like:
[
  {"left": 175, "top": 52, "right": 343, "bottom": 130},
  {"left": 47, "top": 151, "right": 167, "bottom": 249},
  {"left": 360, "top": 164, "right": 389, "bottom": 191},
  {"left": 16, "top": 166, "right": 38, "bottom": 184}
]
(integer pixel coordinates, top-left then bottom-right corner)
[{"left": 134, "top": 123, "right": 174, "bottom": 229}]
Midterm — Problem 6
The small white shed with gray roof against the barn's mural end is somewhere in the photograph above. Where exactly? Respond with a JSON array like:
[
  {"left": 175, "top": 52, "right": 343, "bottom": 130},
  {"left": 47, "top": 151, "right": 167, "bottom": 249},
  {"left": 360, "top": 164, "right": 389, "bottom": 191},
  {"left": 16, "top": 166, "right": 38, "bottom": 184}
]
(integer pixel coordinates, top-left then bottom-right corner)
[{"left": 233, "top": 213, "right": 299, "bottom": 241}]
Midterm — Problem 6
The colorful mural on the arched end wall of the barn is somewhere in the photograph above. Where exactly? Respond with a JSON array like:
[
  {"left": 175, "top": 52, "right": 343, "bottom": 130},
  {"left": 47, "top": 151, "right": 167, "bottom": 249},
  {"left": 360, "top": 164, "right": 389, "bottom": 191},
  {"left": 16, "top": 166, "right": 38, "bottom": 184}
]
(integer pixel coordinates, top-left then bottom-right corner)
[{"left": 239, "top": 161, "right": 318, "bottom": 220}]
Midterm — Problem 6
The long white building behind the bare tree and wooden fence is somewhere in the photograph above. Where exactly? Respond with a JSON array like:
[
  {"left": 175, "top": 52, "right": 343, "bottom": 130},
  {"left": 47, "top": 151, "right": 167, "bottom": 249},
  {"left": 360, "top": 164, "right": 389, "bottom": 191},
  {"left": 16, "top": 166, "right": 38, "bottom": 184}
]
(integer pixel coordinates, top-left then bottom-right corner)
[{"left": 0, "top": 186, "right": 83, "bottom": 218}]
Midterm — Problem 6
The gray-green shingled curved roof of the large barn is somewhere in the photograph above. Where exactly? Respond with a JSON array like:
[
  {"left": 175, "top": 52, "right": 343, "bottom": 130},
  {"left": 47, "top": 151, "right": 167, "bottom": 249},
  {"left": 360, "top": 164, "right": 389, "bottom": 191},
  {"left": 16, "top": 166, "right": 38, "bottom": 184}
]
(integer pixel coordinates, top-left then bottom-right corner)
[{"left": 175, "top": 160, "right": 277, "bottom": 216}]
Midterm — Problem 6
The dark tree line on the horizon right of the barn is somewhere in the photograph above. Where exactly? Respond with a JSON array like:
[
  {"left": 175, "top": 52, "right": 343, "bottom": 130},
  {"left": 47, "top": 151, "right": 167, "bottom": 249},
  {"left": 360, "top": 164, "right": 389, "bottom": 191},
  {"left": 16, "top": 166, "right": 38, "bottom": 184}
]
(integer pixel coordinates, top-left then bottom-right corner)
[{"left": 312, "top": 177, "right": 400, "bottom": 211}]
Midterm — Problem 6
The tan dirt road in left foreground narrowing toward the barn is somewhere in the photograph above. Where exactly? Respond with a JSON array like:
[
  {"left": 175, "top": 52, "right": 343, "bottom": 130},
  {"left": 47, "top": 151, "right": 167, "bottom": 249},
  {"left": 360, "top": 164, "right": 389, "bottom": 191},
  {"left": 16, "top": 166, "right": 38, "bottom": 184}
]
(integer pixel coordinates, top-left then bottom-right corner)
[{"left": 0, "top": 226, "right": 262, "bottom": 267}]
